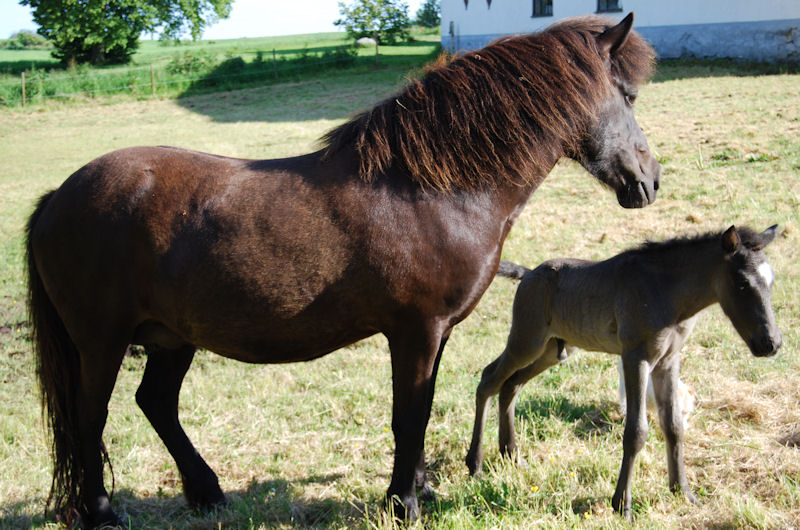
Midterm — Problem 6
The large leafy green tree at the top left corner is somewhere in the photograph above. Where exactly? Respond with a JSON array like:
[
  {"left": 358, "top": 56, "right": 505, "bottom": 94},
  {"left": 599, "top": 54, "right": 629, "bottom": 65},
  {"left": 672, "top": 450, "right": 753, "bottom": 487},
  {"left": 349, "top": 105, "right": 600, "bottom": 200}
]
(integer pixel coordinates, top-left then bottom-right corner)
[{"left": 20, "top": 0, "right": 233, "bottom": 64}]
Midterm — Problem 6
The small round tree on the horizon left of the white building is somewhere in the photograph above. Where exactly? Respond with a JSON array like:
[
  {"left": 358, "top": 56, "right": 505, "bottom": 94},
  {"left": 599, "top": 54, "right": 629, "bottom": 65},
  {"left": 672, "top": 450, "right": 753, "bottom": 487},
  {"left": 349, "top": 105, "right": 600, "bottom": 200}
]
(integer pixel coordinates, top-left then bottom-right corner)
[{"left": 334, "top": 0, "right": 411, "bottom": 44}]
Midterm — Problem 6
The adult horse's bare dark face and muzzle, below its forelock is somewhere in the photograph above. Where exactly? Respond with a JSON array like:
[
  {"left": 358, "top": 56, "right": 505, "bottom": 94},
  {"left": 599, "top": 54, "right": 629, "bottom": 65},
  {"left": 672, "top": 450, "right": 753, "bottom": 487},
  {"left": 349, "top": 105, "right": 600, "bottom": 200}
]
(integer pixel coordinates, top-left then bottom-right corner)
[{"left": 578, "top": 81, "right": 661, "bottom": 208}]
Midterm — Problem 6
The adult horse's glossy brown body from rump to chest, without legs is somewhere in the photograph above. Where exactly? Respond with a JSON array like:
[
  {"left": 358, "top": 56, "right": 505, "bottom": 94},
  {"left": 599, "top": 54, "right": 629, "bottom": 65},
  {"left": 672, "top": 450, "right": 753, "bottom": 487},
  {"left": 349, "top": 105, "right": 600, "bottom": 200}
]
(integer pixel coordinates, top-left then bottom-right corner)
[{"left": 34, "top": 147, "right": 501, "bottom": 362}]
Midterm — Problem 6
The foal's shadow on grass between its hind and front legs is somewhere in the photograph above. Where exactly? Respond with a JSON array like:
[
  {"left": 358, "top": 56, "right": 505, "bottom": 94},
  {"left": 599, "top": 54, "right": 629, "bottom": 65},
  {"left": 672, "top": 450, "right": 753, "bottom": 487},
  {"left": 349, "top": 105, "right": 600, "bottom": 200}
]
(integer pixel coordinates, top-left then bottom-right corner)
[{"left": 515, "top": 396, "right": 625, "bottom": 438}]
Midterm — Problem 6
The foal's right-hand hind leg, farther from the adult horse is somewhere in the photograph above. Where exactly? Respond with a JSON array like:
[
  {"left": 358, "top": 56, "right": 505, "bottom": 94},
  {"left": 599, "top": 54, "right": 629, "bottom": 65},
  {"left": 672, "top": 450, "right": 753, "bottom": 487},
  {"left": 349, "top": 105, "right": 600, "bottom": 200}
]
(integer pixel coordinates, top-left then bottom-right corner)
[{"left": 497, "top": 338, "right": 562, "bottom": 457}]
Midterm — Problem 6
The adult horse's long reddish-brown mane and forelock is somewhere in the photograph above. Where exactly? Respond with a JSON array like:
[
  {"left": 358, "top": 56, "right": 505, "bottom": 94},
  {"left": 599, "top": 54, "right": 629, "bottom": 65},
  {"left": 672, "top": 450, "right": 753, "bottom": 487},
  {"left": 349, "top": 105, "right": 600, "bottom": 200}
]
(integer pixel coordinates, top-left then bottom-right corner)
[{"left": 322, "top": 16, "right": 654, "bottom": 190}]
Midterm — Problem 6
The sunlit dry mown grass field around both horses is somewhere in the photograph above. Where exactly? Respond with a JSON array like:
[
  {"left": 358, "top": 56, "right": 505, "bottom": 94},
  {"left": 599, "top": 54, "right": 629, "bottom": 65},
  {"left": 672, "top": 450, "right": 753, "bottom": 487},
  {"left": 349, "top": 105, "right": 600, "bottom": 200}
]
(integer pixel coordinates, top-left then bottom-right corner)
[{"left": 0, "top": 48, "right": 800, "bottom": 529}]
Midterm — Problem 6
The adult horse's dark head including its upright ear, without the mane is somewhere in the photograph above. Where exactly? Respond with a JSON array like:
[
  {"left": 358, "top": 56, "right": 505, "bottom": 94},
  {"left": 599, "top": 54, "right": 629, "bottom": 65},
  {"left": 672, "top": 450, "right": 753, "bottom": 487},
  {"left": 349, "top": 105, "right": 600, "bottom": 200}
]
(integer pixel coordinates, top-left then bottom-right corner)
[{"left": 571, "top": 13, "right": 661, "bottom": 208}]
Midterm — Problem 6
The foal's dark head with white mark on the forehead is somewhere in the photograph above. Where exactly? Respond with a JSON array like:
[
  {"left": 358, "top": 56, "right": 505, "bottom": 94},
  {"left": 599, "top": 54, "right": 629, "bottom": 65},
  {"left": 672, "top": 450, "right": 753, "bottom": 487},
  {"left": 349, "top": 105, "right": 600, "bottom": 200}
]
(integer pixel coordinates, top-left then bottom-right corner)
[{"left": 715, "top": 225, "right": 782, "bottom": 357}]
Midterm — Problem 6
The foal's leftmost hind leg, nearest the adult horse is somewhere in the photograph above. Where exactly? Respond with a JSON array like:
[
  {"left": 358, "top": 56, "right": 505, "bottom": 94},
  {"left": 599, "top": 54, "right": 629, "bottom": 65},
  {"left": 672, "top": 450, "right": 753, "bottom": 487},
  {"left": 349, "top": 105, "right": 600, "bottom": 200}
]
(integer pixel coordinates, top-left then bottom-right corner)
[{"left": 465, "top": 332, "right": 557, "bottom": 475}]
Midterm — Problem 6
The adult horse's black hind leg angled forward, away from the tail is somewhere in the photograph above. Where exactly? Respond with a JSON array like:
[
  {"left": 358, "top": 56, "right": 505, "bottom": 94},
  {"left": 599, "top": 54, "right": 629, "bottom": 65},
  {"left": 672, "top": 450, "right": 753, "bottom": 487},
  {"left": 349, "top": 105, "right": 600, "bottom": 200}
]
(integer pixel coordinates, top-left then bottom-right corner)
[{"left": 136, "top": 345, "right": 225, "bottom": 508}]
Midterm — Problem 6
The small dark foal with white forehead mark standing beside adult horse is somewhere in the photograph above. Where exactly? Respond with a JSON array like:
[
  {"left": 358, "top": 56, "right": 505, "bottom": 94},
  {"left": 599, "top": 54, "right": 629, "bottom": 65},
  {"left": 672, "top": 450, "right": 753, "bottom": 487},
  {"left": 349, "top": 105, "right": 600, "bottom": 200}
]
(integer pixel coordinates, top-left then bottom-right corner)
[{"left": 466, "top": 225, "right": 781, "bottom": 518}]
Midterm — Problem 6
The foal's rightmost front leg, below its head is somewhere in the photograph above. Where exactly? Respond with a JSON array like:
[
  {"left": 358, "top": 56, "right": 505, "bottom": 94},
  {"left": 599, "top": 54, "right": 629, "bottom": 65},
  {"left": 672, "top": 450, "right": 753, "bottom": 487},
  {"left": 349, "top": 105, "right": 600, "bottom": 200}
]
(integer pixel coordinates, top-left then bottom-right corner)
[{"left": 652, "top": 351, "right": 697, "bottom": 504}]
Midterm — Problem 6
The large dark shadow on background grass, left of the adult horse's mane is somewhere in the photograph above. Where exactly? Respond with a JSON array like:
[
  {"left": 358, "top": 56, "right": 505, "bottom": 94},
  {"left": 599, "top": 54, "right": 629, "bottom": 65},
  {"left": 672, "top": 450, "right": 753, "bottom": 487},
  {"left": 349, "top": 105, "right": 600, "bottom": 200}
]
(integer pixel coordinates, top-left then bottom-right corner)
[{"left": 171, "top": 43, "right": 439, "bottom": 123}]
